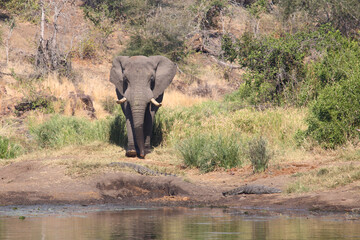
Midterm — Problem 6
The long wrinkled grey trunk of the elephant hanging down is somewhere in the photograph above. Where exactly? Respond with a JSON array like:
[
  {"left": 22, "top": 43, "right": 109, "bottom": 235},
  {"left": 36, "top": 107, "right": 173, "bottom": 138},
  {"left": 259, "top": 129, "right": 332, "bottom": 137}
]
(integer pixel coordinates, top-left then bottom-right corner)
[{"left": 131, "top": 101, "right": 148, "bottom": 158}]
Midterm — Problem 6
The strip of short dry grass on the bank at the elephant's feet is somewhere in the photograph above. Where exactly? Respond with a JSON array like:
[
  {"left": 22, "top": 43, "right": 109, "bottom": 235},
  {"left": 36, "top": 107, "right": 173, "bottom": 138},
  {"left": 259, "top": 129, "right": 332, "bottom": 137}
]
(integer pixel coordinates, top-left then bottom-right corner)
[{"left": 7, "top": 142, "right": 184, "bottom": 177}]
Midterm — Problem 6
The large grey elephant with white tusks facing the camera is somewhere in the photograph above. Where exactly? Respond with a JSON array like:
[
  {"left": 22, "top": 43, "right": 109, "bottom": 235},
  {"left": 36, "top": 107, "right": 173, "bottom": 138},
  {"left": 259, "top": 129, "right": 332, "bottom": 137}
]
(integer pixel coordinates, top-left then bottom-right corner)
[{"left": 110, "top": 56, "right": 177, "bottom": 158}]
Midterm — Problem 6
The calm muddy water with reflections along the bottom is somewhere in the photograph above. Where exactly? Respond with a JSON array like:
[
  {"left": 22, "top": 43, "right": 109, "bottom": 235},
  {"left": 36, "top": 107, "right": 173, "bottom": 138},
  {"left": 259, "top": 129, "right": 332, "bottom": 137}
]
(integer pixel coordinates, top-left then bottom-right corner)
[{"left": 0, "top": 206, "right": 360, "bottom": 239}]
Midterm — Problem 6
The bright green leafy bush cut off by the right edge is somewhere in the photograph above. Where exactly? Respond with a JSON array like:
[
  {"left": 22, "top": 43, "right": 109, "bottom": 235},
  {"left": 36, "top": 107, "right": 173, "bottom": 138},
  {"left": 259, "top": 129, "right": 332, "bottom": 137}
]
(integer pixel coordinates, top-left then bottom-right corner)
[{"left": 307, "top": 39, "right": 360, "bottom": 148}]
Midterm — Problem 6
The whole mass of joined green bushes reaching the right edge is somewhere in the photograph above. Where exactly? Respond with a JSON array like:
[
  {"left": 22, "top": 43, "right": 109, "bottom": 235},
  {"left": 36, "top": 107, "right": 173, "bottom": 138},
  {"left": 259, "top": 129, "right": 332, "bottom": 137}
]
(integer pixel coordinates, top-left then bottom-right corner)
[{"left": 223, "top": 25, "right": 360, "bottom": 148}]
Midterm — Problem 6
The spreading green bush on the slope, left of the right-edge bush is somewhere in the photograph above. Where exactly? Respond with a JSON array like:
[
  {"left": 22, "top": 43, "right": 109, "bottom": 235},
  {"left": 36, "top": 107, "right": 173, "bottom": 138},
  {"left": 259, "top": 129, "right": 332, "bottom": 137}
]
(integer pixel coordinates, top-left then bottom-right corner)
[{"left": 222, "top": 25, "right": 342, "bottom": 105}]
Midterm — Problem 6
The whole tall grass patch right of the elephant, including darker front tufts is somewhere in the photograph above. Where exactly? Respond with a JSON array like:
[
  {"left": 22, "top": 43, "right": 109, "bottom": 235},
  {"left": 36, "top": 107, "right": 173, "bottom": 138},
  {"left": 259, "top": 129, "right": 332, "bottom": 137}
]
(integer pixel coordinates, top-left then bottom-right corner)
[{"left": 154, "top": 101, "right": 306, "bottom": 172}]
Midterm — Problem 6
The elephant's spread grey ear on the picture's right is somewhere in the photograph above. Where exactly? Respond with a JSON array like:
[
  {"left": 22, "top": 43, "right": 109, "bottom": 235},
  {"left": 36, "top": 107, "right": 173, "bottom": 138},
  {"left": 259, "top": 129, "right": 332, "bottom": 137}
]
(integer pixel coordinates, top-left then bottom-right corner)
[{"left": 150, "top": 56, "right": 177, "bottom": 99}]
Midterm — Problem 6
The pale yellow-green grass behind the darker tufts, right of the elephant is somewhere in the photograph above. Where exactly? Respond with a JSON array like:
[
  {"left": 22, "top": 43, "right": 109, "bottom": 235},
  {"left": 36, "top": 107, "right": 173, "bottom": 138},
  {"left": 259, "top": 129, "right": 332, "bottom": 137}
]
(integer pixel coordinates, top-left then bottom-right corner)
[{"left": 156, "top": 101, "right": 307, "bottom": 150}]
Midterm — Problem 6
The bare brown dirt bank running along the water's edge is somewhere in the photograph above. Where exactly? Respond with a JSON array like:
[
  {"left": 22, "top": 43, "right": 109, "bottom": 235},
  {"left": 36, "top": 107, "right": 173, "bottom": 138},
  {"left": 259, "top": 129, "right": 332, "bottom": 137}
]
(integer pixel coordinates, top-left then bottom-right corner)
[{"left": 0, "top": 158, "right": 360, "bottom": 214}]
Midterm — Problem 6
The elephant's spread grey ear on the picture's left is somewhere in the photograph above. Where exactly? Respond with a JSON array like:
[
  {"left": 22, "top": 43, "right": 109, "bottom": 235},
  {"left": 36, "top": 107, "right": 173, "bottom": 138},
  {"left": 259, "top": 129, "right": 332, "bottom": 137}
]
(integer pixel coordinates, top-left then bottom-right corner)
[{"left": 110, "top": 56, "right": 129, "bottom": 96}]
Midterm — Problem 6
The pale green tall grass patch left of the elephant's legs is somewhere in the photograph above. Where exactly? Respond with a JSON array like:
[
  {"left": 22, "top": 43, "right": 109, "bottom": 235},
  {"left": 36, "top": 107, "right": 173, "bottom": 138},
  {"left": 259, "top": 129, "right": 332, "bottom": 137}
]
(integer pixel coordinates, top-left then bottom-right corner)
[{"left": 30, "top": 115, "right": 109, "bottom": 148}]
